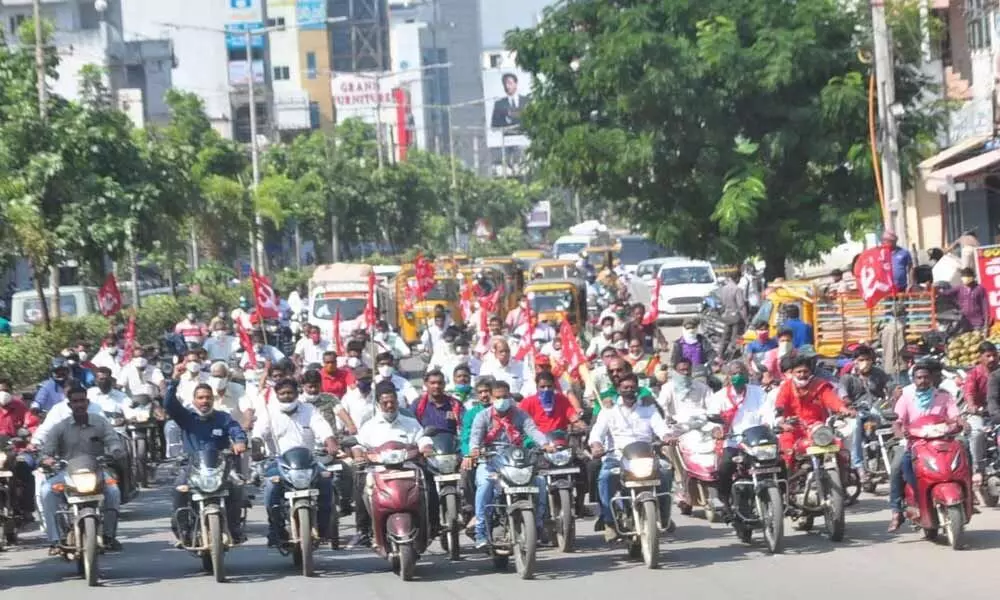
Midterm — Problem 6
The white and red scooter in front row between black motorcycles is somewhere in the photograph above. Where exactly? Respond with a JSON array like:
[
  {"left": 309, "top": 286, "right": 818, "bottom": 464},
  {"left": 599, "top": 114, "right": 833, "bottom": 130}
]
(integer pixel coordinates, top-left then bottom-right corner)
[{"left": 677, "top": 416, "right": 721, "bottom": 523}]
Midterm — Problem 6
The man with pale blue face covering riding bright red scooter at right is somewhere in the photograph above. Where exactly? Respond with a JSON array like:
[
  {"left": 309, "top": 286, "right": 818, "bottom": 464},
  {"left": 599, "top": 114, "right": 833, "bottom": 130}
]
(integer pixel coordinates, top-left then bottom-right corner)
[{"left": 888, "top": 362, "right": 965, "bottom": 533}]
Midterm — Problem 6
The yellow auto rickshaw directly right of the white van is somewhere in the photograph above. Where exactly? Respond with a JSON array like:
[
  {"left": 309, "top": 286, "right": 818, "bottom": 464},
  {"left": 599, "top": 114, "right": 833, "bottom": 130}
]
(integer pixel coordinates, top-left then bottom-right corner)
[{"left": 393, "top": 264, "right": 462, "bottom": 345}]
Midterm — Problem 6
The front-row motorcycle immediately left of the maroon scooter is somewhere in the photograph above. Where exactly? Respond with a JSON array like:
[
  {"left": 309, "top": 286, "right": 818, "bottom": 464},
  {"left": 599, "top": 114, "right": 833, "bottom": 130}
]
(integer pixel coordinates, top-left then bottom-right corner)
[{"left": 277, "top": 448, "right": 344, "bottom": 577}]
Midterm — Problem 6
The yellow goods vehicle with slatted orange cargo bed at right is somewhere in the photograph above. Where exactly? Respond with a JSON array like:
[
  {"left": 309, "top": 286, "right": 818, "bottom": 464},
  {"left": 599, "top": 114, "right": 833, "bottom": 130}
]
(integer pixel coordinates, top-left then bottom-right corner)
[{"left": 742, "top": 281, "right": 937, "bottom": 358}]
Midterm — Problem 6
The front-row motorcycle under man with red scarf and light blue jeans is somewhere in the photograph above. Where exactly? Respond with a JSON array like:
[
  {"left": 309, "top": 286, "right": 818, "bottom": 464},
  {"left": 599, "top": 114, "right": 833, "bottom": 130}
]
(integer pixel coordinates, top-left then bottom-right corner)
[{"left": 482, "top": 444, "right": 541, "bottom": 579}]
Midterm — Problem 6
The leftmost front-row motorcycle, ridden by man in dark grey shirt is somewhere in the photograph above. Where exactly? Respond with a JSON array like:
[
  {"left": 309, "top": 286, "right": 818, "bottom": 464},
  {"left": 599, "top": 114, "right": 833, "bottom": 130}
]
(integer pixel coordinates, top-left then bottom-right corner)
[{"left": 44, "top": 455, "right": 116, "bottom": 587}]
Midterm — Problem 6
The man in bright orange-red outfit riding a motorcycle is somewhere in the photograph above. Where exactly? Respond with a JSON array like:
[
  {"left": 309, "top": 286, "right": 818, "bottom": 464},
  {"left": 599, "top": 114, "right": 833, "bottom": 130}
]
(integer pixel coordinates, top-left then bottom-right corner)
[{"left": 774, "top": 356, "right": 857, "bottom": 467}]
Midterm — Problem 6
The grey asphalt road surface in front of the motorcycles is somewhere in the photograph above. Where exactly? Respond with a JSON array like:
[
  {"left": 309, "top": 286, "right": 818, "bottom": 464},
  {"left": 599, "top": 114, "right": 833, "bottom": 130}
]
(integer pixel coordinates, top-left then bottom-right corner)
[{"left": 0, "top": 474, "right": 1000, "bottom": 600}]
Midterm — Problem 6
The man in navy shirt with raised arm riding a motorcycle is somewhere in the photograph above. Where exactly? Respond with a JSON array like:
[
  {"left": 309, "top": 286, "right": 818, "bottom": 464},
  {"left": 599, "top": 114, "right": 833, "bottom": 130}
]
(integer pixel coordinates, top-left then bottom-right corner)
[{"left": 163, "top": 364, "right": 247, "bottom": 547}]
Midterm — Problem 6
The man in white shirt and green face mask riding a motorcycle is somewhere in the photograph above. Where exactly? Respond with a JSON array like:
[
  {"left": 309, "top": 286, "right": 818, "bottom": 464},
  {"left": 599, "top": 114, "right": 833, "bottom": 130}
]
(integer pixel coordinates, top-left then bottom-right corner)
[{"left": 706, "top": 361, "right": 775, "bottom": 513}]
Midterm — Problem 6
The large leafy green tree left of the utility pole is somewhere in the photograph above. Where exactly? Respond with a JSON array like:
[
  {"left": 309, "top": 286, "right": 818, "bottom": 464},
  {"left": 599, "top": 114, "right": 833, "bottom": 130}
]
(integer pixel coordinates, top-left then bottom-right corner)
[{"left": 507, "top": 0, "right": 940, "bottom": 277}]
